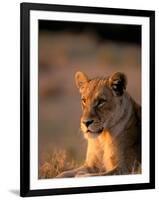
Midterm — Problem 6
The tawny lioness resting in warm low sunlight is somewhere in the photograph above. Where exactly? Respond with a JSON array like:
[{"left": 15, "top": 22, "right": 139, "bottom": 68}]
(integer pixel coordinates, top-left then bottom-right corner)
[{"left": 57, "top": 72, "right": 141, "bottom": 177}]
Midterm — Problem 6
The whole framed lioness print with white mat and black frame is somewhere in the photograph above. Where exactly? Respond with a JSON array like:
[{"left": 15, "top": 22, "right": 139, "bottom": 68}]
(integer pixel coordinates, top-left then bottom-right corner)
[{"left": 20, "top": 3, "right": 155, "bottom": 196}]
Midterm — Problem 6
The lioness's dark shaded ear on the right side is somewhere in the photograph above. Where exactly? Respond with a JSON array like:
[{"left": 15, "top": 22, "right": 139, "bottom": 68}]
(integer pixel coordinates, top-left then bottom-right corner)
[{"left": 109, "top": 72, "right": 127, "bottom": 96}]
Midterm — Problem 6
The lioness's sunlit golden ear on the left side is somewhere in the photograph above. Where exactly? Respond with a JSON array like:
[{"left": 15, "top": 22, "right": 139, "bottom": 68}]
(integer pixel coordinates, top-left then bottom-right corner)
[{"left": 75, "top": 72, "right": 88, "bottom": 89}]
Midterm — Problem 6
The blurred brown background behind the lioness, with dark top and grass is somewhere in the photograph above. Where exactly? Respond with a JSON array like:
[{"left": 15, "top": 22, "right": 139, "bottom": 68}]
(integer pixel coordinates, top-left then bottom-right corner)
[{"left": 38, "top": 20, "right": 141, "bottom": 178}]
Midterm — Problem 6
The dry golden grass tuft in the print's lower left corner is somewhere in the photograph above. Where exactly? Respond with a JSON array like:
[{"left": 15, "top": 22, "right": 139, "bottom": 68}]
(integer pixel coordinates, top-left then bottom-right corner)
[{"left": 39, "top": 150, "right": 77, "bottom": 179}]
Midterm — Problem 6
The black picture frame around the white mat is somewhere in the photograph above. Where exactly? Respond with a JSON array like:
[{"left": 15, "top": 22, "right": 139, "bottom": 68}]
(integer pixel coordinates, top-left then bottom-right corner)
[{"left": 20, "top": 3, "right": 155, "bottom": 197}]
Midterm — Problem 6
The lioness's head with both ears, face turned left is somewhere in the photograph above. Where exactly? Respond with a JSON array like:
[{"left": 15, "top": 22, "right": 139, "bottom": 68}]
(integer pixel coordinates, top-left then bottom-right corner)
[{"left": 75, "top": 72, "right": 127, "bottom": 137}]
